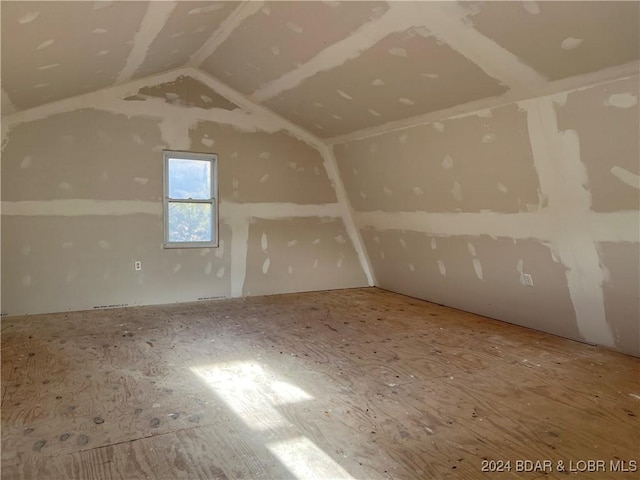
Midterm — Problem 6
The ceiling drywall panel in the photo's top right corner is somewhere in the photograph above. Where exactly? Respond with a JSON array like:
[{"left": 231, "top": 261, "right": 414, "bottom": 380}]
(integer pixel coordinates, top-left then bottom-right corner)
[{"left": 465, "top": 1, "right": 640, "bottom": 80}]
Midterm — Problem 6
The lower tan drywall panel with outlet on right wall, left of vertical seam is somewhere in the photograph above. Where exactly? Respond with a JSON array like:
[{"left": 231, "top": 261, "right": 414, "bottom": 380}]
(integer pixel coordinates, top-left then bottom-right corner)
[{"left": 363, "top": 228, "right": 579, "bottom": 338}]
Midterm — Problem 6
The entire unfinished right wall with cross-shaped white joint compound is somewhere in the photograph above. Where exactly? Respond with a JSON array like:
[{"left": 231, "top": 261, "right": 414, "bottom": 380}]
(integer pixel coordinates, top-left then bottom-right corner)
[{"left": 334, "top": 75, "right": 640, "bottom": 355}]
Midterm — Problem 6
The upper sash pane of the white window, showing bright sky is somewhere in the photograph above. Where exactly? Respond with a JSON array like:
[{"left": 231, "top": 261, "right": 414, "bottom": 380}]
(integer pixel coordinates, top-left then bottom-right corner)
[{"left": 168, "top": 158, "right": 211, "bottom": 200}]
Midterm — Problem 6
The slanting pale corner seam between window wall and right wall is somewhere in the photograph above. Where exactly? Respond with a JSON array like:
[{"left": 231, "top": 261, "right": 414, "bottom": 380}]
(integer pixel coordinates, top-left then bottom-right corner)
[{"left": 320, "top": 146, "right": 376, "bottom": 287}]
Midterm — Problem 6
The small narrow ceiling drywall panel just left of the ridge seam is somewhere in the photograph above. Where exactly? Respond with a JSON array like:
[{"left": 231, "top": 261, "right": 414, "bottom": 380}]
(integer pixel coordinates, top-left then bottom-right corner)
[{"left": 134, "top": 1, "right": 237, "bottom": 78}]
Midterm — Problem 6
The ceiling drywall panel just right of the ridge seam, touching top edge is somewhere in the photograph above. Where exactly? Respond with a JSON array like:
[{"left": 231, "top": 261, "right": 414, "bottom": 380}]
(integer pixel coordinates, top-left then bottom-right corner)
[{"left": 201, "top": 2, "right": 388, "bottom": 94}]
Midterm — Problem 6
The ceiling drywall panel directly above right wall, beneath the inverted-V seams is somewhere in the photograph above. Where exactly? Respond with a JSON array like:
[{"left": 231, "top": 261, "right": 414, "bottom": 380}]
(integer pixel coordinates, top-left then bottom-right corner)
[{"left": 265, "top": 28, "right": 507, "bottom": 137}]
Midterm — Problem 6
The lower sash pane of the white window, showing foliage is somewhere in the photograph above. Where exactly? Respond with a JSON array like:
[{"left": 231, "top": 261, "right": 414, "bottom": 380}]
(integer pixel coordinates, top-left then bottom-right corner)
[{"left": 168, "top": 202, "right": 213, "bottom": 242}]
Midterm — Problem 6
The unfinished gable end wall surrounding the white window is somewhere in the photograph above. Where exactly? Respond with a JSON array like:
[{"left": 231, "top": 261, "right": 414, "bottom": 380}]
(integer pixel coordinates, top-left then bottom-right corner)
[{"left": 1, "top": 70, "right": 368, "bottom": 315}]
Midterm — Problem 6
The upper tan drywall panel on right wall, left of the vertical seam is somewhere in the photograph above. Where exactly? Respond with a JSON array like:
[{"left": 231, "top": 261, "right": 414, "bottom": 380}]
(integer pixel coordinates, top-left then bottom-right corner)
[{"left": 336, "top": 105, "right": 539, "bottom": 213}]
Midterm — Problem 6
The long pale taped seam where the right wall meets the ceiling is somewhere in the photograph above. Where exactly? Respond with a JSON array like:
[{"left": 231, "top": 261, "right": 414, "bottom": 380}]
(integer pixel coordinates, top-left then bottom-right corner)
[{"left": 325, "top": 67, "right": 640, "bottom": 145}]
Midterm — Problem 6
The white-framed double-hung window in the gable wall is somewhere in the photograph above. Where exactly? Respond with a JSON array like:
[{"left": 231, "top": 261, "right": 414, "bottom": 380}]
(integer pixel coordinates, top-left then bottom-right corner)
[{"left": 164, "top": 150, "right": 218, "bottom": 248}]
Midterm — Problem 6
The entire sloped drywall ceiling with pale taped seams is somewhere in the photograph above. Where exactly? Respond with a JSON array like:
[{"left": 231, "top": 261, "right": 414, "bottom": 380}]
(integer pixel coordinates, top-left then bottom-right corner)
[{"left": 1, "top": 1, "right": 640, "bottom": 138}]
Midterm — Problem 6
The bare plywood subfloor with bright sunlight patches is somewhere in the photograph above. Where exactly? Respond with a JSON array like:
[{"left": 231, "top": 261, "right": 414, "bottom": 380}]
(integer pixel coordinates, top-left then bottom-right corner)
[{"left": 2, "top": 288, "right": 640, "bottom": 480}]
